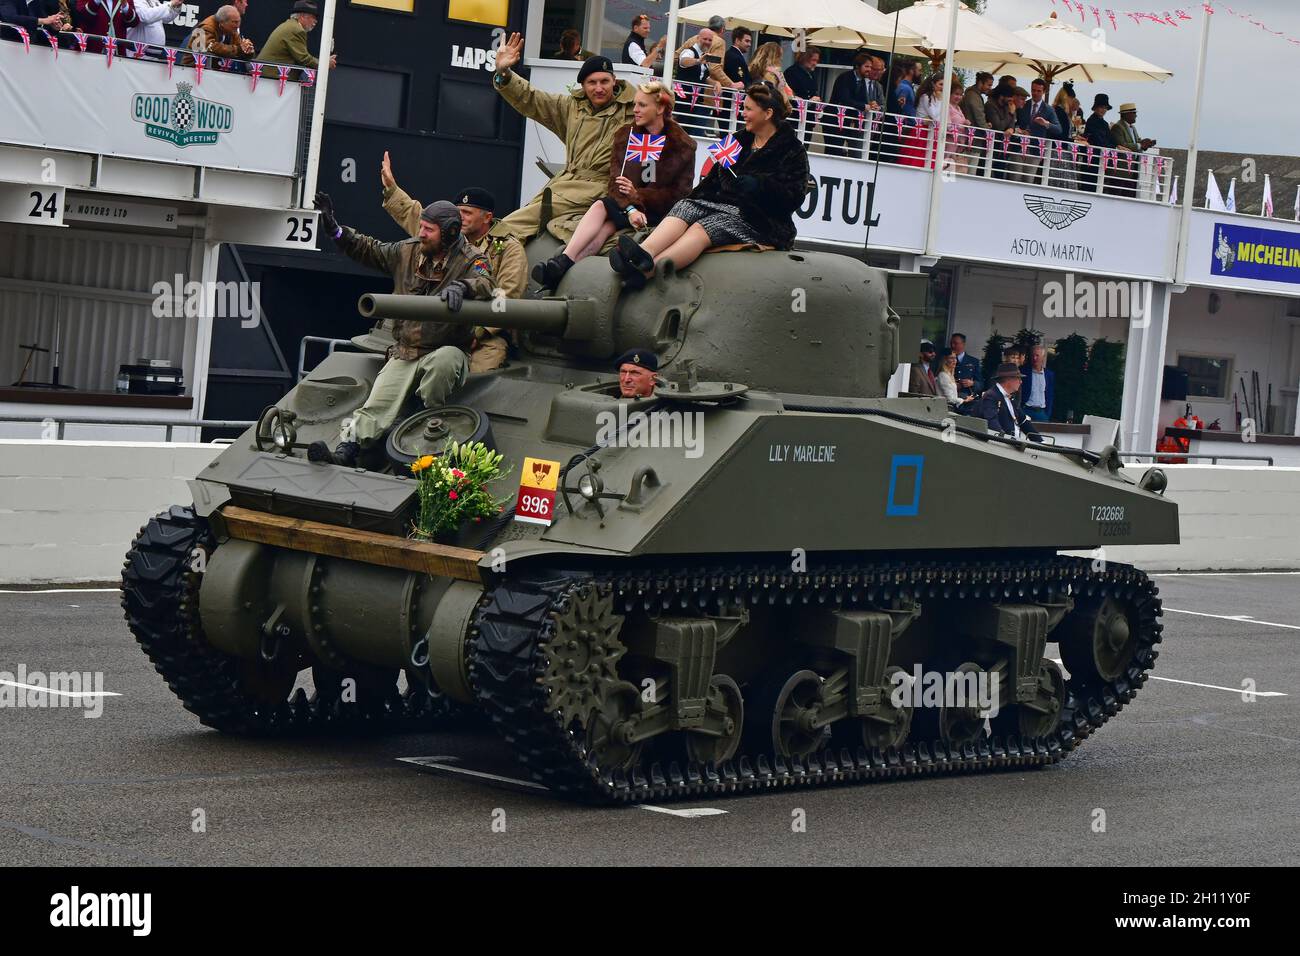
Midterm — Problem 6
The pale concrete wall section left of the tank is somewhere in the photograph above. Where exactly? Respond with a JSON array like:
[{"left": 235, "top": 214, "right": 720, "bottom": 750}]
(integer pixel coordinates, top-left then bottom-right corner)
[{"left": 0, "top": 440, "right": 222, "bottom": 584}]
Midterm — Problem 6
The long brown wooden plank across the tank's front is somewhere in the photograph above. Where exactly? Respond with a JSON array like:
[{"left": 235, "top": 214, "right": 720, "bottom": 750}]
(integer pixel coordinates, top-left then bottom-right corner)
[{"left": 221, "top": 505, "right": 484, "bottom": 581}]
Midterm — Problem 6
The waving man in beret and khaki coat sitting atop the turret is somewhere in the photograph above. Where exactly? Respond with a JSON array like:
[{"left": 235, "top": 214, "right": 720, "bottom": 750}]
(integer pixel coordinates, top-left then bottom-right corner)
[{"left": 491, "top": 34, "right": 634, "bottom": 242}]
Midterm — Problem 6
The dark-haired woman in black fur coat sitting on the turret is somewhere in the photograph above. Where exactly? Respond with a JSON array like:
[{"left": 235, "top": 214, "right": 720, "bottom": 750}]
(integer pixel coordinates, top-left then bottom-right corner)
[{"left": 610, "top": 83, "right": 809, "bottom": 289}]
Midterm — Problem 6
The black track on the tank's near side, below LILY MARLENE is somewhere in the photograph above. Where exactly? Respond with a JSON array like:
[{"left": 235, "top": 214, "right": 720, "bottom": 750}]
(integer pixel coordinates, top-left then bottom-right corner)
[{"left": 471, "top": 557, "right": 1162, "bottom": 803}]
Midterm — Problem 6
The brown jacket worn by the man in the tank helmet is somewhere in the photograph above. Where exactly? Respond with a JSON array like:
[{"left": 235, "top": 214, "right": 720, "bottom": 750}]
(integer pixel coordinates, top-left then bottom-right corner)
[{"left": 338, "top": 226, "right": 494, "bottom": 360}]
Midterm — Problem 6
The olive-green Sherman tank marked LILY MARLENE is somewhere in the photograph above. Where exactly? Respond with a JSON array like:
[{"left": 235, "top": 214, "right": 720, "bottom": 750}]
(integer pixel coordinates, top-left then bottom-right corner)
[{"left": 122, "top": 246, "right": 1178, "bottom": 801}]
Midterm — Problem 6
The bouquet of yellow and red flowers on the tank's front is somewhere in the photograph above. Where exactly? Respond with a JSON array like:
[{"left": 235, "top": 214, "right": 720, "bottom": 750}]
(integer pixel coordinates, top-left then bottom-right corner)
[{"left": 411, "top": 441, "right": 510, "bottom": 540}]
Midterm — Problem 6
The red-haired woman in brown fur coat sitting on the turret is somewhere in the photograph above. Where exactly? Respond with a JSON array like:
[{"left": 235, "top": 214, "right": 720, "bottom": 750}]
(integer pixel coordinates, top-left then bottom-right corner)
[{"left": 533, "top": 79, "right": 696, "bottom": 289}]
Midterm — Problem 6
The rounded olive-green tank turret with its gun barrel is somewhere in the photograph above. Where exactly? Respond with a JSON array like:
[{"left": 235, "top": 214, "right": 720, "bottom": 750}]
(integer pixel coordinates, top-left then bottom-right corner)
[{"left": 358, "top": 252, "right": 905, "bottom": 398}]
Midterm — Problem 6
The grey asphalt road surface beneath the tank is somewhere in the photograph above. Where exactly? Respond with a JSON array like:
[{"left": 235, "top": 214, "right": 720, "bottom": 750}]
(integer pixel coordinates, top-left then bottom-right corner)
[{"left": 0, "top": 574, "right": 1300, "bottom": 866}]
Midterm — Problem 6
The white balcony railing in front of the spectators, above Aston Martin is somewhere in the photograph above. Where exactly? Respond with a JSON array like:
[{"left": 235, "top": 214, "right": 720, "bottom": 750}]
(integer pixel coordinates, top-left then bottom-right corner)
[{"left": 673, "top": 82, "right": 1173, "bottom": 203}]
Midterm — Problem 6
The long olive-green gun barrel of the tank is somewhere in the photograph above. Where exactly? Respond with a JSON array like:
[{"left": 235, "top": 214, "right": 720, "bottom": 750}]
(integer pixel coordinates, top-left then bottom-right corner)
[{"left": 356, "top": 293, "right": 585, "bottom": 338}]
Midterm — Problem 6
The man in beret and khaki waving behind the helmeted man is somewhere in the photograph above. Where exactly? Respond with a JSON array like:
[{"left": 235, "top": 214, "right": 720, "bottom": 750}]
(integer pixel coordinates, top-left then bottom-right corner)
[{"left": 380, "top": 151, "right": 528, "bottom": 372}]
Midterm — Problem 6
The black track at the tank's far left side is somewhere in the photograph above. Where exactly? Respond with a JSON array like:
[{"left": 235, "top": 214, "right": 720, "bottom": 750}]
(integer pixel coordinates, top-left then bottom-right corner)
[{"left": 122, "top": 506, "right": 462, "bottom": 736}]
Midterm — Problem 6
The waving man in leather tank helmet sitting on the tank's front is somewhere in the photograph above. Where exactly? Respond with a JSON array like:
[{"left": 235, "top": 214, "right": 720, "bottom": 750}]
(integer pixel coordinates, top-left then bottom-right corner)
[{"left": 307, "top": 193, "right": 494, "bottom": 467}]
